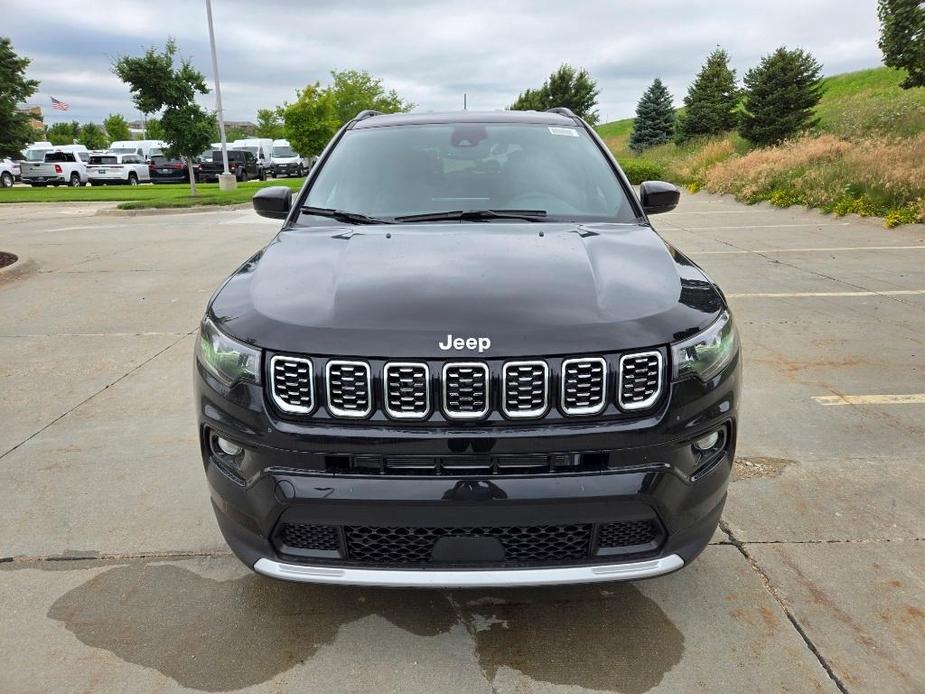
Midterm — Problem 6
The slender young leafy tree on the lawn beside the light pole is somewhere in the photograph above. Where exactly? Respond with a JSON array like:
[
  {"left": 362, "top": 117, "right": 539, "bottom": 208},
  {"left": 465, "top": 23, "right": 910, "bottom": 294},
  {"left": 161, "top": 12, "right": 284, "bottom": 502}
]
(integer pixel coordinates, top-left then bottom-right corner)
[{"left": 113, "top": 39, "right": 215, "bottom": 195}]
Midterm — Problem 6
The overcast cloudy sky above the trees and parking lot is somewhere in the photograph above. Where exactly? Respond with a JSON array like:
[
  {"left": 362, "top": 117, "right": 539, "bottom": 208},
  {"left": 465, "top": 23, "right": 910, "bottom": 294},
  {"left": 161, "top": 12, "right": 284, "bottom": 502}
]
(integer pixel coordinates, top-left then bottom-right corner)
[{"left": 0, "top": 0, "right": 880, "bottom": 123}]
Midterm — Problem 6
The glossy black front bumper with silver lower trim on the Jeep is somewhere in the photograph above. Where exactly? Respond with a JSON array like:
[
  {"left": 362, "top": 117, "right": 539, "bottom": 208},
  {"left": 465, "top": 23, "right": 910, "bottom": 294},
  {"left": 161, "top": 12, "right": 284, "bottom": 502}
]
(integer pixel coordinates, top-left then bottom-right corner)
[{"left": 196, "top": 354, "right": 739, "bottom": 587}]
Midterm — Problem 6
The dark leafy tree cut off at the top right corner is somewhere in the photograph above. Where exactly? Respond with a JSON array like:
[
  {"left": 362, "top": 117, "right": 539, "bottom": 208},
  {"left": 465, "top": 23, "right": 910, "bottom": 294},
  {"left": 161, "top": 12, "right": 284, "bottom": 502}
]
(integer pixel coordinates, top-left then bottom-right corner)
[{"left": 877, "top": 0, "right": 925, "bottom": 89}]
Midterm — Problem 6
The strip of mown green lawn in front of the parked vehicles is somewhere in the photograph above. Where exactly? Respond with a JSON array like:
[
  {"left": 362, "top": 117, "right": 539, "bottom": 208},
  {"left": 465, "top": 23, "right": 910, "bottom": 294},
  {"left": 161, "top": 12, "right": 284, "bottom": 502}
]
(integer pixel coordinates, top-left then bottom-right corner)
[{"left": 0, "top": 178, "right": 303, "bottom": 210}]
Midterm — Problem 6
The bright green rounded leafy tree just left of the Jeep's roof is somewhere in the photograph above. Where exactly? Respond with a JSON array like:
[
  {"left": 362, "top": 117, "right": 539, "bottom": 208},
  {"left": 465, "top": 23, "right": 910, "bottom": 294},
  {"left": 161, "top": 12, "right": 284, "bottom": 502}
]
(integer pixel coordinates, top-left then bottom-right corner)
[{"left": 281, "top": 70, "right": 414, "bottom": 156}]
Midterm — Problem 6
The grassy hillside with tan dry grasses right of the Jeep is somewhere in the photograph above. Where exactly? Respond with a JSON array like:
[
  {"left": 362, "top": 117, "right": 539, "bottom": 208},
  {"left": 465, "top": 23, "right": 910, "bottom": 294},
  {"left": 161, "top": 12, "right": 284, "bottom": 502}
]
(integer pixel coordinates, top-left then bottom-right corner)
[{"left": 597, "top": 67, "right": 925, "bottom": 226}]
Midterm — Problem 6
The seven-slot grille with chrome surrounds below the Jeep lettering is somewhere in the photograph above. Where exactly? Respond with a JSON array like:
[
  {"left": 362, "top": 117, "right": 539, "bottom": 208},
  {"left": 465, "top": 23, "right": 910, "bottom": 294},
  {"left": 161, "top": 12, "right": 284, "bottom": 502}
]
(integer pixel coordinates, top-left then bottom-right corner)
[{"left": 267, "top": 350, "right": 667, "bottom": 421}]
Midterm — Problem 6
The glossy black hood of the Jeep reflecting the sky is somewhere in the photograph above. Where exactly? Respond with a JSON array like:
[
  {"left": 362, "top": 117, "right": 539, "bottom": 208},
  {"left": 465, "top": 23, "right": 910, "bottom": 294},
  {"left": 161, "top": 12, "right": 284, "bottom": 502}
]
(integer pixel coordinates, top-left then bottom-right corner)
[{"left": 211, "top": 223, "right": 723, "bottom": 358}]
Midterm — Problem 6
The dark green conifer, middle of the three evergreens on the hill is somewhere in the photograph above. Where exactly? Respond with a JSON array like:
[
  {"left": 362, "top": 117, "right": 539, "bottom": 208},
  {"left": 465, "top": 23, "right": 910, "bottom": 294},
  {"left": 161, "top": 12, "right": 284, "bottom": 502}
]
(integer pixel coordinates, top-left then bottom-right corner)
[{"left": 677, "top": 48, "right": 739, "bottom": 141}]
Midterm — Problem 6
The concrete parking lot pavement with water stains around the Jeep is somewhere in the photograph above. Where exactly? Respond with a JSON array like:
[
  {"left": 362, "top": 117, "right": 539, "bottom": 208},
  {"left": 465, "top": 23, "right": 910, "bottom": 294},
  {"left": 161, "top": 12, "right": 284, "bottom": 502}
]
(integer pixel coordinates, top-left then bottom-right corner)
[{"left": 0, "top": 194, "right": 925, "bottom": 693}]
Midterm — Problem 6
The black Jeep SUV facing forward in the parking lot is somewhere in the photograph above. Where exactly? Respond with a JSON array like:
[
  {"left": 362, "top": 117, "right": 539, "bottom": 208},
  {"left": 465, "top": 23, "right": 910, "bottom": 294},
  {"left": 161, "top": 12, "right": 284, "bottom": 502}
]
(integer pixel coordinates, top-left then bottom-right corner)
[{"left": 195, "top": 109, "right": 740, "bottom": 586}]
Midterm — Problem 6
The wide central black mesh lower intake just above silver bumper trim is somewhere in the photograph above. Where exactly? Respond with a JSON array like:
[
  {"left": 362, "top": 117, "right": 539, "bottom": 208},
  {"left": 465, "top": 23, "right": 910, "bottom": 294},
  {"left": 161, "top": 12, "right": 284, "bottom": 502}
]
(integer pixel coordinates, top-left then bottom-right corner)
[{"left": 344, "top": 524, "right": 591, "bottom": 565}]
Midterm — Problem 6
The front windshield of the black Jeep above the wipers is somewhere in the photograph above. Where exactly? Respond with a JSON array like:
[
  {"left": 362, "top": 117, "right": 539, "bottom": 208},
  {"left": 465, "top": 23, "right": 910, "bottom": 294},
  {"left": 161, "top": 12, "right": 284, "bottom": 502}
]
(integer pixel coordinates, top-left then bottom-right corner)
[{"left": 305, "top": 123, "right": 636, "bottom": 223}]
